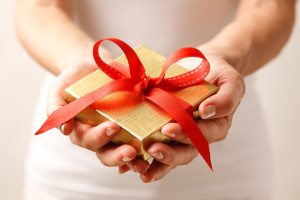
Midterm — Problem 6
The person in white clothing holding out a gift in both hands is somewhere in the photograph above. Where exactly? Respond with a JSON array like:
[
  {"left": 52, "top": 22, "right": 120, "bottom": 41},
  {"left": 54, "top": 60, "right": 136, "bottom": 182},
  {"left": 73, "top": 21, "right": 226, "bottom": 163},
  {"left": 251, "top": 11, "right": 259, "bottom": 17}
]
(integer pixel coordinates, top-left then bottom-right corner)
[{"left": 17, "top": 0, "right": 295, "bottom": 200}]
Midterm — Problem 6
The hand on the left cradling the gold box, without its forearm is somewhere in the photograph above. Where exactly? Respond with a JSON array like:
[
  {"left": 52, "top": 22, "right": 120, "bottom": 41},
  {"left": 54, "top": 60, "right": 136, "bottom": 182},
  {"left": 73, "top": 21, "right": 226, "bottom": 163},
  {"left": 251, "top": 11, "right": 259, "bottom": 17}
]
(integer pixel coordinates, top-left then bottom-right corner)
[{"left": 47, "top": 63, "right": 149, "bottom": 174}]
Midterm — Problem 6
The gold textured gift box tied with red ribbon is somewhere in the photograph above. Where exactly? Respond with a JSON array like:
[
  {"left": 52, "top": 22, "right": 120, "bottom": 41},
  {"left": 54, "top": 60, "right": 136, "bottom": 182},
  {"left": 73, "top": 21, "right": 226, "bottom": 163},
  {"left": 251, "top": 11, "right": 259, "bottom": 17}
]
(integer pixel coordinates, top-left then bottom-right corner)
[{"left": 65, "top": 46, "right": 217, "bottom": 160}]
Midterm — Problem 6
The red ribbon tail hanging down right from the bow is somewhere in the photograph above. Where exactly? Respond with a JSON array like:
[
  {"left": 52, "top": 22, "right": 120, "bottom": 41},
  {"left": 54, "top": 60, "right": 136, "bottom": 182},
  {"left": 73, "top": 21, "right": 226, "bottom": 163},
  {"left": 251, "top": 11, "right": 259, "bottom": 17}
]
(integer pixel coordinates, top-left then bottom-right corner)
[{"left": 146, "top": 88, "right": 212, "bottom": 170}]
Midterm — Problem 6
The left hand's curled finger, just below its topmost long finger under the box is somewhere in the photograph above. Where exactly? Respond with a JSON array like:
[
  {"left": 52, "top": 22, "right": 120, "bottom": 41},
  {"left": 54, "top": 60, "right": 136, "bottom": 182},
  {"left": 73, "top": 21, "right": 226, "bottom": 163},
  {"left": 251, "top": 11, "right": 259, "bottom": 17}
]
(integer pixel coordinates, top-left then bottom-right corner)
[{"left": 96, "top": 144, "right": 137, "bottom": 167}]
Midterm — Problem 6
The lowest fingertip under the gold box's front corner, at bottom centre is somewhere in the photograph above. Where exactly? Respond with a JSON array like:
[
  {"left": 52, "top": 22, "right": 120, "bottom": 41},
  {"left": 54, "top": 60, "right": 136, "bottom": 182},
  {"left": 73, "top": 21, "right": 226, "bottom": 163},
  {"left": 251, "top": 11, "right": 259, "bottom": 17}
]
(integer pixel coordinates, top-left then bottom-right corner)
[{"left": 140, "top": 160, "right": 176, "bottom": 183}]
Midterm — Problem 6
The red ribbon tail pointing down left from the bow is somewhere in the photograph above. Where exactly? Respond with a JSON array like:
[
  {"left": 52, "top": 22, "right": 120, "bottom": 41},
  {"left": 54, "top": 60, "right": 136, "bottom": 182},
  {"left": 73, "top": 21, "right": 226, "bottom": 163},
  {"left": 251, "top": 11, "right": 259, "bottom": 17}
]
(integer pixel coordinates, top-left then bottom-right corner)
[{"left": 35, "top": 79, "right": 132, "bottom": 135}]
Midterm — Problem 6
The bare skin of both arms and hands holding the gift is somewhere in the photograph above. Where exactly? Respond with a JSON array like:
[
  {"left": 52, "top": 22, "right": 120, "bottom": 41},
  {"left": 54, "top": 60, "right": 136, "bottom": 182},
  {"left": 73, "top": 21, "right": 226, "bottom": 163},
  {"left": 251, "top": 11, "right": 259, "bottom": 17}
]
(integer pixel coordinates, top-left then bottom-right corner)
[{"left": 16, "top": 0, "right": 295, "bottom": 183}]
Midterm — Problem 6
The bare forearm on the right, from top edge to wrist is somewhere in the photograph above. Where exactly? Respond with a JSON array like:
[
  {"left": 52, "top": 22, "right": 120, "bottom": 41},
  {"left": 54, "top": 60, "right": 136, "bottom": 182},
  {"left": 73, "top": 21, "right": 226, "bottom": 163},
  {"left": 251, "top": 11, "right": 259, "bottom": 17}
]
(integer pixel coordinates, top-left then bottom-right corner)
[{"left": 200, "top": 0, "right": 295, "bottom": 76}]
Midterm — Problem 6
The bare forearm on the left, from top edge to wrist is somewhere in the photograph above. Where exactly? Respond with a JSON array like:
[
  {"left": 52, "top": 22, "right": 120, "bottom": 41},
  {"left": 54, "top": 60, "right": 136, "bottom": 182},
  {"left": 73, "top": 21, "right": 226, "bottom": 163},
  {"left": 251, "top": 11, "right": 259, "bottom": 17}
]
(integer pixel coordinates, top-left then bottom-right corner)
[{"left": 16, "top": 0, "right": 94, "bottom": 75}]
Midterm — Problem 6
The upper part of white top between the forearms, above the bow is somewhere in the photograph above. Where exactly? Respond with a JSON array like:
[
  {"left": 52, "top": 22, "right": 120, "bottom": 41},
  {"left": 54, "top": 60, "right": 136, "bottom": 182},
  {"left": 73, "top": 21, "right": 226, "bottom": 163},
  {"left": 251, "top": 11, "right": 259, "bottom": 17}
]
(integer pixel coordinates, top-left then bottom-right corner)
[{"left": 76, "top": 0, "right": 237, "bottom": 56}]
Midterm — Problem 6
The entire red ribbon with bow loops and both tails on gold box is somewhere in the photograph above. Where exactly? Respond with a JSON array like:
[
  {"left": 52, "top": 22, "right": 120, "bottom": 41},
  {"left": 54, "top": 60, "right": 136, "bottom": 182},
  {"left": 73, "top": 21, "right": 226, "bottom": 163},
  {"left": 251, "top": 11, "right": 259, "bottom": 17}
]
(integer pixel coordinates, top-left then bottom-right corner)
[{"left": 35, "top": 38, "right": 212, "bottom": 169}]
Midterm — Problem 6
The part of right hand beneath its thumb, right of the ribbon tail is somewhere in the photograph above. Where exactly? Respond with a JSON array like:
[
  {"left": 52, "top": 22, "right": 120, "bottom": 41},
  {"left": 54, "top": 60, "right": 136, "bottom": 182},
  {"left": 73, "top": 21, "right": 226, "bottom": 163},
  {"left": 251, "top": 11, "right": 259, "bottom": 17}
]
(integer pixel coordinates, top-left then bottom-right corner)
[{"left": 197, "top": 114, "right": 232, "bottom": 143}]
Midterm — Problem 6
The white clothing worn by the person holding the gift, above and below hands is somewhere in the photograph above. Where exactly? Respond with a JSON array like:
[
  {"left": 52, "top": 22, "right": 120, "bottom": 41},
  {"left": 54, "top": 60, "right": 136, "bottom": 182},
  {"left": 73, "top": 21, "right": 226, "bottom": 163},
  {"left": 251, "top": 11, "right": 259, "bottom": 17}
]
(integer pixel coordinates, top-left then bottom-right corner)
[{"left": 27, "top": 0, "right": 270, "bottom": 200}]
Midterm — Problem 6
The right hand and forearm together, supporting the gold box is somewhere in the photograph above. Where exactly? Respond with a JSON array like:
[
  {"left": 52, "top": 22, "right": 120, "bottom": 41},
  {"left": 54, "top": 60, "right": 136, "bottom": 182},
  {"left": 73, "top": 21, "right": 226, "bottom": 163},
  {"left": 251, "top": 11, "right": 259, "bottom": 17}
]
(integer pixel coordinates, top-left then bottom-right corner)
[{"left": 137, "top": 0, "right": 295, "bottom": 182}]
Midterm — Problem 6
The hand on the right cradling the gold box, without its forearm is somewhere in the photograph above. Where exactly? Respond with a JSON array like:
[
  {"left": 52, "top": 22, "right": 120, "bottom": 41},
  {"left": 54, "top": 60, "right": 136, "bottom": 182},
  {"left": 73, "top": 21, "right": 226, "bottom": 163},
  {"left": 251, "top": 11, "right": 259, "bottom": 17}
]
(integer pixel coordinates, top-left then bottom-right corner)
[{"left": 140, "top": 54, "right": 245, "bottom": 182}]
